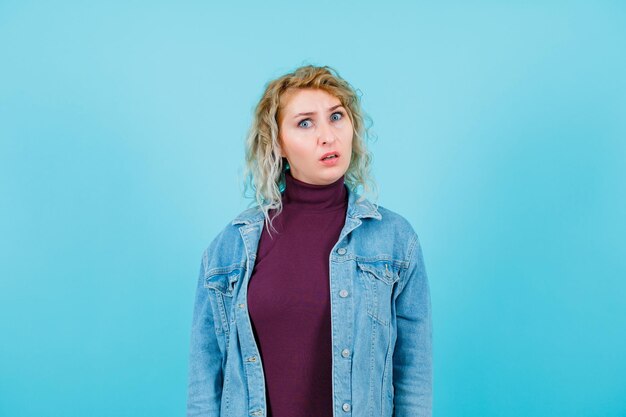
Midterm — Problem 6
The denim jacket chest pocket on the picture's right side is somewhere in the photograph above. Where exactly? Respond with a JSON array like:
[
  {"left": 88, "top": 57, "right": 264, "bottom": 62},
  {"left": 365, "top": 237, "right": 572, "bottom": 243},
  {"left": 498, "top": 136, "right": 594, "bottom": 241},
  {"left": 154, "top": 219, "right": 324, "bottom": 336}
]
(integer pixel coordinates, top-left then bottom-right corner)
[{"left": 357, "top": 260, "right": 400, "bottom": 326}]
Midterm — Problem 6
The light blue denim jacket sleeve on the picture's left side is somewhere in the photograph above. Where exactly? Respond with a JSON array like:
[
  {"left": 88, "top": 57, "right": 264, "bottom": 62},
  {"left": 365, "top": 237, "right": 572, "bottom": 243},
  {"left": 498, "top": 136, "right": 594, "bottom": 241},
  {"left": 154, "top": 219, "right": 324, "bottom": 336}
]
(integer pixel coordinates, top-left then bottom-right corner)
[{"left": 187, "top": 249, "right": 223, "bottom": 417}]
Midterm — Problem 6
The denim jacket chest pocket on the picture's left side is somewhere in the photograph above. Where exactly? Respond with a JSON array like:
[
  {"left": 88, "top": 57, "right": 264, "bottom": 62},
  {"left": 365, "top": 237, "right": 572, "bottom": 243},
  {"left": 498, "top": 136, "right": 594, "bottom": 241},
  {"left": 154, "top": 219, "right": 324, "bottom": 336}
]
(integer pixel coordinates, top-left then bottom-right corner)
[{"left": 204, "top": 265, "right": 245, "bottom": 334}]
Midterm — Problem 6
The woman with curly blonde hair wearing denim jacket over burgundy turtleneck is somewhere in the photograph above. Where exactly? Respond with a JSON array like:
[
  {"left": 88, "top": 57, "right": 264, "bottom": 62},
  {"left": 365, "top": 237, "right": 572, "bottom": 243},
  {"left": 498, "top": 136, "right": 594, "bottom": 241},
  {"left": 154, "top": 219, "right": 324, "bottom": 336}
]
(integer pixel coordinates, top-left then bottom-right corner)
[{"left": 187, "top": 66, "right": 432, "bottom": 417}]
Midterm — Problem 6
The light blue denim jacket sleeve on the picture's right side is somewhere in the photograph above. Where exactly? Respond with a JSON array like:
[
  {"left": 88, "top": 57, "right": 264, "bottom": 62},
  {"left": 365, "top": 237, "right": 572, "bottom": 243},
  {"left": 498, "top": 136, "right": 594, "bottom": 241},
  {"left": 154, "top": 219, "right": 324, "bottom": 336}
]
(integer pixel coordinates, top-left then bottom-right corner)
[{"left": 393, "top": 235, "right": 433, "bottom": 417}]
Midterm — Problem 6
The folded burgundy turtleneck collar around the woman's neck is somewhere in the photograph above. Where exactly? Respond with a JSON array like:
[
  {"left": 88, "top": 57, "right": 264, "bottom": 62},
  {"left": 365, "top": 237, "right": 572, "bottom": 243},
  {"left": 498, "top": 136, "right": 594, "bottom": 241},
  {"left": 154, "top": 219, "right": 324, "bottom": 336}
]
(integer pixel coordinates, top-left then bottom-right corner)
[{"left": 283, "top": 170, "right": 348, "bottom": 211}]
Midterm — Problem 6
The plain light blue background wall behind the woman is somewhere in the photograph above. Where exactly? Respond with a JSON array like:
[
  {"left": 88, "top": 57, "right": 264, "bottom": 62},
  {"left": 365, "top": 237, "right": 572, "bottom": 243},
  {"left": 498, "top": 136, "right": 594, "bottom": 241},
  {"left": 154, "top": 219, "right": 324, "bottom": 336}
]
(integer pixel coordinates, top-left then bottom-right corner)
[{"left": 0, "top": 0, "right": 626, "bottom": 417}]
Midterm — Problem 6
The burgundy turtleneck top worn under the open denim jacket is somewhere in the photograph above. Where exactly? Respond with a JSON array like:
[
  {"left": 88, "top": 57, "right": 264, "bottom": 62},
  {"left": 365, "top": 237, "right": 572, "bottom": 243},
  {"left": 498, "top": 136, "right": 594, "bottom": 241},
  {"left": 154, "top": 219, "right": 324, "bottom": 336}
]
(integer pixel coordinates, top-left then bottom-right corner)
[{"left": 248, "top": 170, "right": 348, "bottom": 417}]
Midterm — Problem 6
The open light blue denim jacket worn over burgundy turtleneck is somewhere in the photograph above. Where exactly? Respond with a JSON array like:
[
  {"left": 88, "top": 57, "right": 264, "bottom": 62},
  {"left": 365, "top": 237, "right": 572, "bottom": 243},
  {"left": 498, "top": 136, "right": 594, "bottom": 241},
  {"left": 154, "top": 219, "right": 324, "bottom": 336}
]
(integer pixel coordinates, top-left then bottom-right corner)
[{"left": 187, "top": 190, "right": 432, "bottom": 417}]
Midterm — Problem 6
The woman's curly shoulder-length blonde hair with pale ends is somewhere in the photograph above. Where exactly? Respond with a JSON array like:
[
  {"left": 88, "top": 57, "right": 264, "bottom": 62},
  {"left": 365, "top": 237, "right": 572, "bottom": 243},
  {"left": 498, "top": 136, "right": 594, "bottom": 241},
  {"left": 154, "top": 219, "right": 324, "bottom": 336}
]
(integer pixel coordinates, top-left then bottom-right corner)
[{"left": 244, "top": 65, "right": 378, "bottom": 236}]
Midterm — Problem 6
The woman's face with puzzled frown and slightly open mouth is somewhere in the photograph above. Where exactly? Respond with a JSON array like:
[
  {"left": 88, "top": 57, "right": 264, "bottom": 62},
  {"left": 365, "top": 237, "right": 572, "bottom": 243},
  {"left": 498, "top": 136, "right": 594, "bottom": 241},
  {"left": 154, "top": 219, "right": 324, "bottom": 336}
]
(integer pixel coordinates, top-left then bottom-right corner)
[{"left": 278, "top": 89, "right": 353, "bottom": 185}]
